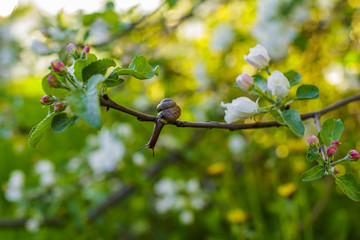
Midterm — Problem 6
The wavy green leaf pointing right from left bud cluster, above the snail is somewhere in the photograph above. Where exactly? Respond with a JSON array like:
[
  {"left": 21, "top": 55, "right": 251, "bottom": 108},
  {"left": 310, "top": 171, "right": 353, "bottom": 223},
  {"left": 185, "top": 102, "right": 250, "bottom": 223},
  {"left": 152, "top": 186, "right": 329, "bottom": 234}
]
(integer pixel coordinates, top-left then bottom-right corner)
[{"left": 114, "top": 56, "right": 159, "bottom": 80}]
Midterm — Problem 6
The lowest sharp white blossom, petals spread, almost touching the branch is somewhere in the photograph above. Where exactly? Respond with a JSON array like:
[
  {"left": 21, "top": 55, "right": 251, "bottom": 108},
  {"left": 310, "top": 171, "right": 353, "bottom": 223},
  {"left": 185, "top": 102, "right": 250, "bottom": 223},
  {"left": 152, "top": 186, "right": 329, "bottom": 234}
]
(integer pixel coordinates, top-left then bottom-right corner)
[{"left": 221, "top": 97, "right": 257, "bottom": 123}]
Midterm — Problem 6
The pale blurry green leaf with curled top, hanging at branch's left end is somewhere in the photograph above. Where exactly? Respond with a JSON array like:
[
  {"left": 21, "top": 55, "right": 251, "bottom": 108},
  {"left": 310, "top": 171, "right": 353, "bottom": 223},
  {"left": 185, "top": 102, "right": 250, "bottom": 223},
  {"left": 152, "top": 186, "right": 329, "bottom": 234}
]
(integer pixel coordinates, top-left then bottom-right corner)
[{"left": 67, "top": 74, "right": 105, "bottom": 128}]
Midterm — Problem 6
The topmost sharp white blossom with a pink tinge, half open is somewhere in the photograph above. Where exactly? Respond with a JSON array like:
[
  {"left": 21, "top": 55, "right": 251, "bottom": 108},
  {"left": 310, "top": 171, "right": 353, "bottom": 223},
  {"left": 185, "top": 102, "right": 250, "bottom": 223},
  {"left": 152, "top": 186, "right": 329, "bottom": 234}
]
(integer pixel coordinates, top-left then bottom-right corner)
[{"left": 244, "top": 44, "right": 270, "bottom": 69}]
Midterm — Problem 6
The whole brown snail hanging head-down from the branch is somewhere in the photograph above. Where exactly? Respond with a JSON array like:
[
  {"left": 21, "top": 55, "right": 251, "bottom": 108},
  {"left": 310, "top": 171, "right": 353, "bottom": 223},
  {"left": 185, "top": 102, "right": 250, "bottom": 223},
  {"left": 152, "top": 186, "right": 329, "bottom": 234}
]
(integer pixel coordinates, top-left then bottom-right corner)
[{"left": 138, "top": 98, "right": 181, "bottom": 156}]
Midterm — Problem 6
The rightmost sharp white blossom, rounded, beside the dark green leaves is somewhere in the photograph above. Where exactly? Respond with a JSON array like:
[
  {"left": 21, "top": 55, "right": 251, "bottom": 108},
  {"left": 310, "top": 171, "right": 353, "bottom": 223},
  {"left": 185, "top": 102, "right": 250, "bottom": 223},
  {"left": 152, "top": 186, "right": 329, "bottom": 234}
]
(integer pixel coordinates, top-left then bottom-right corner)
[{"left": 267, "top": 70, "right": 290, "bottom": 98}]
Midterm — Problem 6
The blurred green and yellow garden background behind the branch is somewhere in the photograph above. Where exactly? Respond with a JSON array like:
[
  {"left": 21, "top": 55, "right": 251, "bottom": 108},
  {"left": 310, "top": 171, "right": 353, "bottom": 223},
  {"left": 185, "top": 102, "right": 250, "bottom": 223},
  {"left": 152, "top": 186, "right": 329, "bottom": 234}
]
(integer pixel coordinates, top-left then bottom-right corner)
[{"left": 0, "top": 0, "right": 360, "bottom": 240}]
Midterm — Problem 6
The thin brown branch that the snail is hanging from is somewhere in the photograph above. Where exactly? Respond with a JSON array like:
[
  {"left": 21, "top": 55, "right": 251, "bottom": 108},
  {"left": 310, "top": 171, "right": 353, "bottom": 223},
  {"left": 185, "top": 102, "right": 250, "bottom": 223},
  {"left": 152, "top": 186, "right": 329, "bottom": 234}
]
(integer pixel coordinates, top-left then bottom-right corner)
[{"left": 100, "top": 94, "right": 360, "bottom": 130}]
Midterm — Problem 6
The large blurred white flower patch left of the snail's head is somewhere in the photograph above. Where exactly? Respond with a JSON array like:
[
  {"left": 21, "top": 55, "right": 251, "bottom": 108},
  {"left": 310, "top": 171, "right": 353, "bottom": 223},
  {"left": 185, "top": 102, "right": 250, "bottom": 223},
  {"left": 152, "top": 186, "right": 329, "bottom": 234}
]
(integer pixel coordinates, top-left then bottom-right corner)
[{"left": 89, "top": 129, "right": 125, "bottom": 173}]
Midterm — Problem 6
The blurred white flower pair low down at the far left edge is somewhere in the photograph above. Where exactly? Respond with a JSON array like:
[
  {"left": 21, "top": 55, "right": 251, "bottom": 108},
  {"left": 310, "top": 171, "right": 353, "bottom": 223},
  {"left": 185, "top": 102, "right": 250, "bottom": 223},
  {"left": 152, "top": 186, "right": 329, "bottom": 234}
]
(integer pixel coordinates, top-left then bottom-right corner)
[{"left": 4, "top": 170, "right": 25, "bottom": 202}]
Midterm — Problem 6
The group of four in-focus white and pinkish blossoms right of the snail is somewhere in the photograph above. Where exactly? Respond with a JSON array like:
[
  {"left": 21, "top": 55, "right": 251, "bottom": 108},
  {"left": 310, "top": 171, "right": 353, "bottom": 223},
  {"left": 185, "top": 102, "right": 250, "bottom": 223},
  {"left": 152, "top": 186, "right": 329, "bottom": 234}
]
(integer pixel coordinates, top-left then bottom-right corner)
[{"left": 221, "top": 44, "right": 290, "bottom": 123}]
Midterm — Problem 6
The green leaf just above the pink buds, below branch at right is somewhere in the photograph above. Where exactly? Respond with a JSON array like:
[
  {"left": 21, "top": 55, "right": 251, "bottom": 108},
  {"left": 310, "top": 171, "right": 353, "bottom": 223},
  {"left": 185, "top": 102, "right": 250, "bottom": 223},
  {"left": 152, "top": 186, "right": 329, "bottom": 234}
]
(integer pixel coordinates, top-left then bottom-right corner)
[{"left": 318, "top": 118, "right": 344, "bottom": 146}]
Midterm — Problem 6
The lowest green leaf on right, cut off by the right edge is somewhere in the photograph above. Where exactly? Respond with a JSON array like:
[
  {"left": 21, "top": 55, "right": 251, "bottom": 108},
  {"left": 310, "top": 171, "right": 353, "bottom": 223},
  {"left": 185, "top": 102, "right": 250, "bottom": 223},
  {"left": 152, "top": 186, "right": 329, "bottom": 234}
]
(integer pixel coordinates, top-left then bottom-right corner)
[{"left": 335, "top": 173, "right": 360, "bottom": 201}]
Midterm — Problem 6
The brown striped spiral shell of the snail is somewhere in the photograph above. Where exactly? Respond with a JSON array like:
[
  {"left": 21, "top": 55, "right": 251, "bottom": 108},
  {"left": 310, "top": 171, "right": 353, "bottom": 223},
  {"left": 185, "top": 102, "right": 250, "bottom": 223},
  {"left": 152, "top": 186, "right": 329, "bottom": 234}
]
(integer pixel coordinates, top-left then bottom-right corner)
[{"left": 157, "top": 98, "right": 181, "bottom": 124}]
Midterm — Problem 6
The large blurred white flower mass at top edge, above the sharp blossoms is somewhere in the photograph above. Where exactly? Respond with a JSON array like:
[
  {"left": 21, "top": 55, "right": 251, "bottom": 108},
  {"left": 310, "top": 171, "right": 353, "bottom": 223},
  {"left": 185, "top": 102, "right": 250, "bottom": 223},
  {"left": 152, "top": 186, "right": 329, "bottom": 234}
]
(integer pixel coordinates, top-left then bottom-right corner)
[{"left": 252, "top": 0, "right": 311, "bottom": 60}]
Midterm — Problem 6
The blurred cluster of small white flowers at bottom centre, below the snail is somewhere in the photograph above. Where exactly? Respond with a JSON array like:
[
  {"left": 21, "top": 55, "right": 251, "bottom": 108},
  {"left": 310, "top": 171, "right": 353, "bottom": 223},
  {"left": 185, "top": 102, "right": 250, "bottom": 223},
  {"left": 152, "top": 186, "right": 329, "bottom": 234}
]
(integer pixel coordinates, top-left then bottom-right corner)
[{"left": 155, "top": 178, "right": 206, "bottom": 225}]
